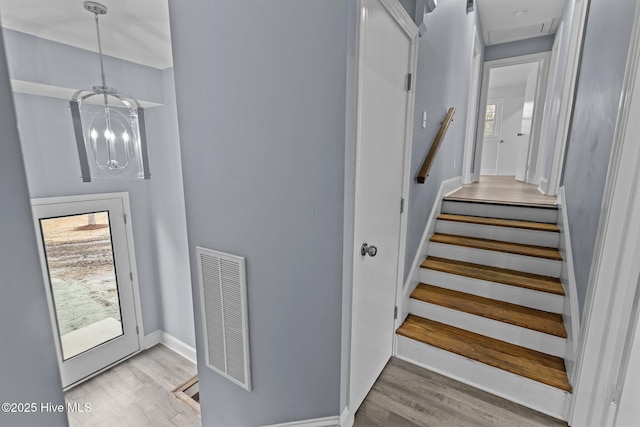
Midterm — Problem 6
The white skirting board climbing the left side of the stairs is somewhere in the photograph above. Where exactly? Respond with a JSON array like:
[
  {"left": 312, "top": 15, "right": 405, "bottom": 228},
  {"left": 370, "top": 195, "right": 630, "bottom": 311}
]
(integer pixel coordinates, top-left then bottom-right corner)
[{"left": 396, "top": 176, "right": 462, "bottom": 329}]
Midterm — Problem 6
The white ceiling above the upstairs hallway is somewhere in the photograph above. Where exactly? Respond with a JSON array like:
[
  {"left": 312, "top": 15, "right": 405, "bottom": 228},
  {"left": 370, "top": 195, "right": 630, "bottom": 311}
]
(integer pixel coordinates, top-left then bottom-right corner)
[{"left": 477, "top": 0, "right": 571, "bottom": 46}]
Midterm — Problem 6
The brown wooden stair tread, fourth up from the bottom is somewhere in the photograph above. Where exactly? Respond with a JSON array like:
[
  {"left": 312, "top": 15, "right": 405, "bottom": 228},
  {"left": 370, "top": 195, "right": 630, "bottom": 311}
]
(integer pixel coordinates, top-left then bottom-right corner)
[{"left": 430, "top": 233, "right": 562, "bottom": 261}]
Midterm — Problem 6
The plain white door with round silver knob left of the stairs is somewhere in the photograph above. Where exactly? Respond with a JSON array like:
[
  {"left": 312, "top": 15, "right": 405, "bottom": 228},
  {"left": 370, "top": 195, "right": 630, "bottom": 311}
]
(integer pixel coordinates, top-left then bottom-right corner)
[{"left": 349, "top": 0, "right": 417, "bottom": 412}]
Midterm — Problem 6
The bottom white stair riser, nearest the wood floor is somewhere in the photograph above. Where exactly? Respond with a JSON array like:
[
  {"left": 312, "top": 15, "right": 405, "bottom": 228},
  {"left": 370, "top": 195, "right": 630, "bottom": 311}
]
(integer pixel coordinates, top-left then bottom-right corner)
[{"left": 397, "top": 335, "right": 569, "bottom": 420}]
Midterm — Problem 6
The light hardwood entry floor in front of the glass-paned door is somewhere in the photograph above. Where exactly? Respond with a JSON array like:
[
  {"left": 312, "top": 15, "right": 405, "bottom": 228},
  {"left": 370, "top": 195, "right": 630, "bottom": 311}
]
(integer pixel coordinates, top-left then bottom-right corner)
[{"left": 65, "top": 345, "right": 201, "bottom": 427}]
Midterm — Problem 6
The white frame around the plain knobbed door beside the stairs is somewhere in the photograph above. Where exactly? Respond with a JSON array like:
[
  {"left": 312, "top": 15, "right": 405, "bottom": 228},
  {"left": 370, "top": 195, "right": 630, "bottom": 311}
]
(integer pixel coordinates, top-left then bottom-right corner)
[{"left": 345, "top": 0, "right": 419, "bottom": 420}]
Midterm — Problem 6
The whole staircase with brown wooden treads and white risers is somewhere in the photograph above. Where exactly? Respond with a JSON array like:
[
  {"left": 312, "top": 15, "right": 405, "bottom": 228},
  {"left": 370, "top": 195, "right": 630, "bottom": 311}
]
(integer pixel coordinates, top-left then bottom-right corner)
[{"left": 397, "top": 198, "right": 571, "bottom": 419}]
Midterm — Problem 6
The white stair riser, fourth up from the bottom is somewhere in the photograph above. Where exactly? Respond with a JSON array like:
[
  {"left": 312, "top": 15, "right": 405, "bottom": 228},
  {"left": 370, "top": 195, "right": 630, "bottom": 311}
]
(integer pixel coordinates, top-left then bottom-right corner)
[{"left": 429, "top": 242, "right": 562, "bottom": 277}]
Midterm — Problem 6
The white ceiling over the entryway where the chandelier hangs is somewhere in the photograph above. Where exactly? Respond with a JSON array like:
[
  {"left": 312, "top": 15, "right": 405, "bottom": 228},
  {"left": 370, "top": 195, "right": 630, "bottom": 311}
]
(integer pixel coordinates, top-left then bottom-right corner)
[{"left": 0, "top": 0, "right": 173, "bottom": 70}]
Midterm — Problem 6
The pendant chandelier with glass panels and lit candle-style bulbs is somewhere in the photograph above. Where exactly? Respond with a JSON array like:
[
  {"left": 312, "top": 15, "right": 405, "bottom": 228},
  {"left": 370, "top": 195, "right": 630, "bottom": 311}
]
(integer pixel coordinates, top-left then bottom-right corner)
[{"left": 70, "top": 1, "right": 151, "bottom": 182}]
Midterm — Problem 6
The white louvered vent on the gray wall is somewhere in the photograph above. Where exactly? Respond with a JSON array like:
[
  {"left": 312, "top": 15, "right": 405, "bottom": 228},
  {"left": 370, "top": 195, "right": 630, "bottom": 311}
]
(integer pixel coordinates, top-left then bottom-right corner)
[{"left": 196, "top": 247, "right": 251, "bottom": 391}]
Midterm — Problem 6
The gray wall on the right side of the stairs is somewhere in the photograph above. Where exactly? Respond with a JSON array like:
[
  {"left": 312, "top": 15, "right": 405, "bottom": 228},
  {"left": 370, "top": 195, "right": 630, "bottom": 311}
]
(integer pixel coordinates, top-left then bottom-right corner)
[{"left": 562, "top": 0, "right": 636, "bottom": 313}]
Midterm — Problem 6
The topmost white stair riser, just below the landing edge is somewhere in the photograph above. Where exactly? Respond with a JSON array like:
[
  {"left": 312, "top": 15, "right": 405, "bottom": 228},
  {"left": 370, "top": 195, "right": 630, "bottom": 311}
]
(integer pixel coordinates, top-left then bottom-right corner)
[{"left": 442, "top": 200, "right": 558, "bottom": 224}]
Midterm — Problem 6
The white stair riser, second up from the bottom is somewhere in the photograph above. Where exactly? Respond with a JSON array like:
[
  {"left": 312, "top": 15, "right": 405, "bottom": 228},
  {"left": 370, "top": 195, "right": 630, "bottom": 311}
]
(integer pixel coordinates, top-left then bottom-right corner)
[{"left": 409, "top": 299, "right": 567, "bottom": 357}]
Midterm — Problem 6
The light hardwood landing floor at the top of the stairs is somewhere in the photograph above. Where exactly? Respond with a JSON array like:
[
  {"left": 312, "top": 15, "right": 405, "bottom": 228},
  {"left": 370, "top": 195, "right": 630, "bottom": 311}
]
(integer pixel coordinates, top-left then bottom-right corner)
[{"left": 448, "top": 175, "right": 556, "bottom": 205}]
